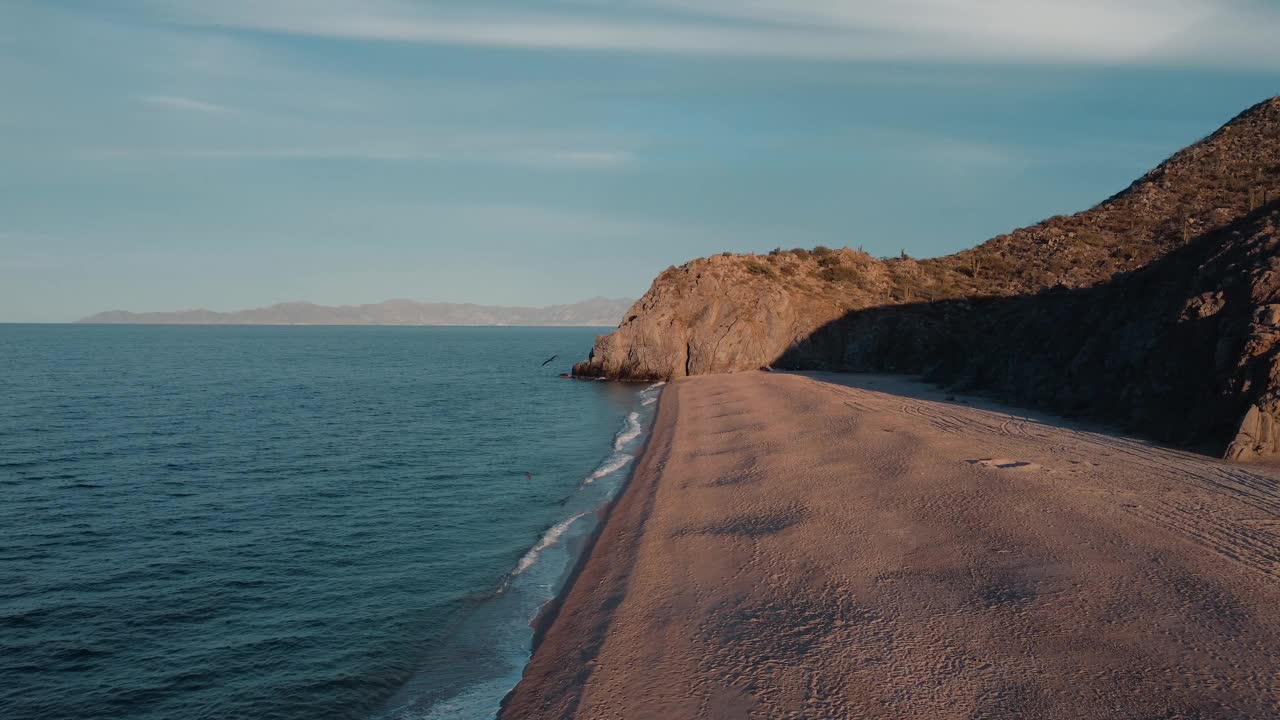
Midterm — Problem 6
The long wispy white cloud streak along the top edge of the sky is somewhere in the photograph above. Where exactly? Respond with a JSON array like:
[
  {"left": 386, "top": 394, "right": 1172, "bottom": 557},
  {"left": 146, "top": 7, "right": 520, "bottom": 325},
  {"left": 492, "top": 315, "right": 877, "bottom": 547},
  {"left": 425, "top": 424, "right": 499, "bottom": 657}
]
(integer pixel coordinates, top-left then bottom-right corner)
[{"left": 145, "top": 0, "right": 1280, "bottom": 68}]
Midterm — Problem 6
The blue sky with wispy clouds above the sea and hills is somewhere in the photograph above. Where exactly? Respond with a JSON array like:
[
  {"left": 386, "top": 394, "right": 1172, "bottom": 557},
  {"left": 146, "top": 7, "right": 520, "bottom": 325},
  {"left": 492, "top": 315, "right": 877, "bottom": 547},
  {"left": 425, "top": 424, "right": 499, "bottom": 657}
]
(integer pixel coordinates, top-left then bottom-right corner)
[{"left": 0, "top": 0, "right": 1280, "bottom": 322}]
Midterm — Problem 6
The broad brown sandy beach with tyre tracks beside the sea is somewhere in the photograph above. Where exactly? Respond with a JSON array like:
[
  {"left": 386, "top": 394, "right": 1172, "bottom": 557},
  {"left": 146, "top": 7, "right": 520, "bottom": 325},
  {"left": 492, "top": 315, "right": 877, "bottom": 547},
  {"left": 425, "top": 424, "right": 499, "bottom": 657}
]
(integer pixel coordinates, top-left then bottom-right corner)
[{"left": 503, "top": 373, "right": 1280, "bottom": 720}]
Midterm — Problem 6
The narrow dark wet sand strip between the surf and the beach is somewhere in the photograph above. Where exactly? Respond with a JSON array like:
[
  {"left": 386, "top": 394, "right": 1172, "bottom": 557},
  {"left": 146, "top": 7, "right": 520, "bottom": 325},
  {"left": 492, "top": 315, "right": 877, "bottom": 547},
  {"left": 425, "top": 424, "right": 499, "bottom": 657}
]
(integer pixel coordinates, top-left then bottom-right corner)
[{"left": 498, "top": 383, "right": 677, "bottom": 720}]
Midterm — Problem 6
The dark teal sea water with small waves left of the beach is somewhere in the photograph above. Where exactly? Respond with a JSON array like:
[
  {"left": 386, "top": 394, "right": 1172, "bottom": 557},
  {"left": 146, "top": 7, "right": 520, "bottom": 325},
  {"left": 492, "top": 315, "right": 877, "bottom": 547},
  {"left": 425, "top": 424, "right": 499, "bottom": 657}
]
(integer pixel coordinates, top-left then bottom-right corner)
[{"left": 0, "top": 325, "right": 659, "bottom": 720}]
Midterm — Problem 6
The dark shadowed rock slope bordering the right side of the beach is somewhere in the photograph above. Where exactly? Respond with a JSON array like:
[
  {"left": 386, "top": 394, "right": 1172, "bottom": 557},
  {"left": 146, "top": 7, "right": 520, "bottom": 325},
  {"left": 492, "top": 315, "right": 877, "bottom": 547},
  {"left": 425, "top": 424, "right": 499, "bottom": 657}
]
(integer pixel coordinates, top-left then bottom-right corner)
[{"left": 774, "top": 202, "right": 1280, "bottom": 460}]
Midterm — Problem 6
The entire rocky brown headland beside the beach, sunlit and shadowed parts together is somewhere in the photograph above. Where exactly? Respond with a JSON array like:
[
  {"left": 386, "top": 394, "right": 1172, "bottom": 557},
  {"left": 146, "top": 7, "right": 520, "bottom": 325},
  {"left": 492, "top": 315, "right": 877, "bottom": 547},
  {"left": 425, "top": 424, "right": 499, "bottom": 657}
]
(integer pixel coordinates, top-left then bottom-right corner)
[{"left": 573, "top": 99, "right": 1280, "bottom": 459}]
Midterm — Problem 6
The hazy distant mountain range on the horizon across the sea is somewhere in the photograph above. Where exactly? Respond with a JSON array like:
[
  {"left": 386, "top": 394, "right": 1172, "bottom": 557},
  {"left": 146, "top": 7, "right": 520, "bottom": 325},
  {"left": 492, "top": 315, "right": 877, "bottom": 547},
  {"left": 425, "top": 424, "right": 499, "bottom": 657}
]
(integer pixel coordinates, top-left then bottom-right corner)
[{"left": 77, "top": 297, "right": 634, "bottom": 327}]
